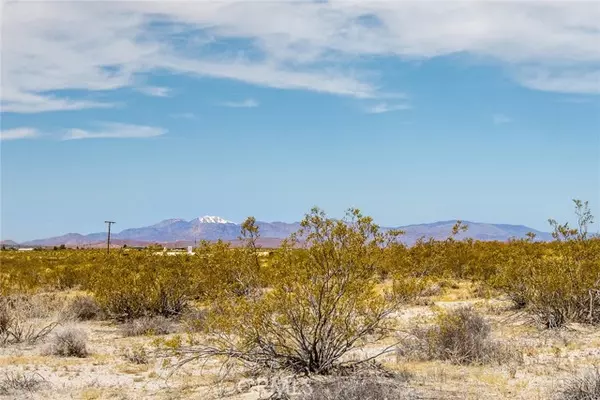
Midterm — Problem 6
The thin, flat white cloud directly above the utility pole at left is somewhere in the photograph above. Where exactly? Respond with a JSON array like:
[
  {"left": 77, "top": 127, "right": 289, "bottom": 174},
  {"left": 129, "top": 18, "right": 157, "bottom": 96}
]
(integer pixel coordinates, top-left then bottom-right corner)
[{"left": 63, "top": 123, "right": 167, "bottom": 140}]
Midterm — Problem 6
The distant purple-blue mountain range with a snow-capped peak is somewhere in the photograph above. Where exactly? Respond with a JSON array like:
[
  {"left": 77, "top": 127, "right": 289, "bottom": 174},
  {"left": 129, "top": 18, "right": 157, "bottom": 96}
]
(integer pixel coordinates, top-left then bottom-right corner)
[{"left": 1, "top": 215, "right": 551, "bottom": 247}]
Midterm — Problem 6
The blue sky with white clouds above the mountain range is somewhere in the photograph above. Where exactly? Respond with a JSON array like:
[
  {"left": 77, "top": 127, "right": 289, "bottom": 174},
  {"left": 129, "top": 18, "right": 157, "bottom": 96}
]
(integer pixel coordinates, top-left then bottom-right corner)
[{"left": 0, "top": 1, "right": 600, "bottom": 241}]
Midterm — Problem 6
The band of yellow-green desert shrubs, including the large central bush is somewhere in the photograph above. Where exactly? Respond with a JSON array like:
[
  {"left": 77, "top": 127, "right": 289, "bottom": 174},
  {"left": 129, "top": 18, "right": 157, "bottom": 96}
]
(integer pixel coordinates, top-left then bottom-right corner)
[{"left": 0, "top": 200, "right": 600, "bottom": 382}]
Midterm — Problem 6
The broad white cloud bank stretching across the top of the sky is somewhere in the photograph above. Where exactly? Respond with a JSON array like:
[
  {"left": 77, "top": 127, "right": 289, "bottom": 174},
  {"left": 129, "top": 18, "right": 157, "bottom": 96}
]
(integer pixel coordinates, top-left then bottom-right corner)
[{"left": 1, "top": 0, "right": 600, "bottom": 112}]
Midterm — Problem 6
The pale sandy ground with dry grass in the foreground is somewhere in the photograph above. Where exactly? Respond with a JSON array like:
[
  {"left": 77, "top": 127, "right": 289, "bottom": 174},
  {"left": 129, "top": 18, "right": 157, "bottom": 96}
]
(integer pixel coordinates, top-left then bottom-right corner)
[{"left": 0, "top": 282, "right": 600, "bottom": 400}]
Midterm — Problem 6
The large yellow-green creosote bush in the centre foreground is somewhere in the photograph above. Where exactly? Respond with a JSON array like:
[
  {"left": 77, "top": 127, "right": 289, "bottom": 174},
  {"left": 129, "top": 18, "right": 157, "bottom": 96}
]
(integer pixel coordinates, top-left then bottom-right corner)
[{"left": 176, "top": 209, "right": 422, "bottom": 374}]
